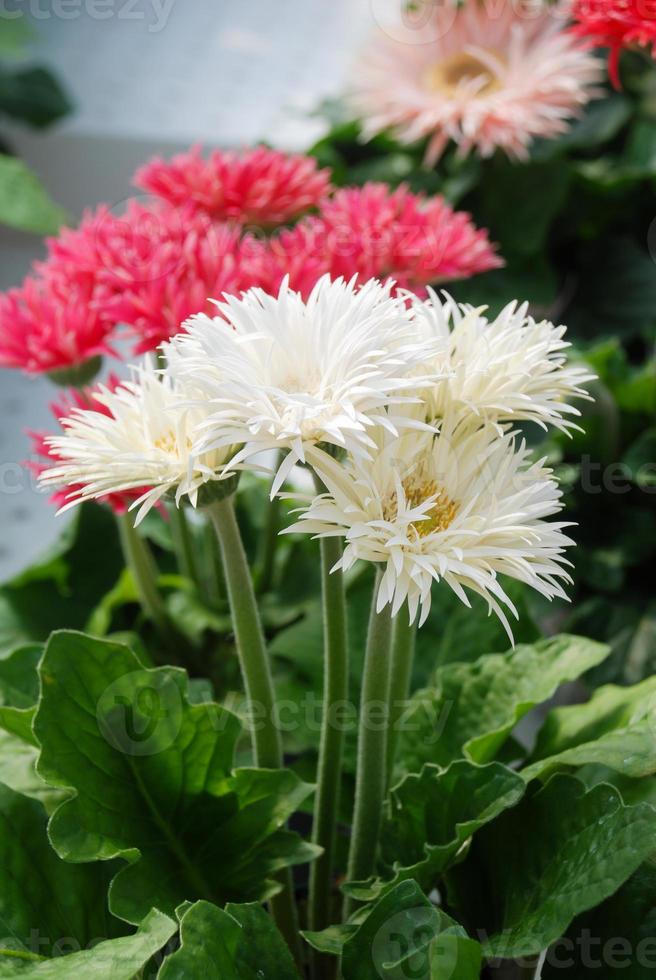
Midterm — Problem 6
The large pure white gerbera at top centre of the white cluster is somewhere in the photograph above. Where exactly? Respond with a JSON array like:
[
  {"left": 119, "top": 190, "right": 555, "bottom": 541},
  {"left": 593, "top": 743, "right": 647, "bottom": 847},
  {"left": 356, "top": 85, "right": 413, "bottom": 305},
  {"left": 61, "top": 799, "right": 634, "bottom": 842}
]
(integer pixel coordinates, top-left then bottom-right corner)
[{"left": 168, "top": 276, "right": 446, "bottom": 493}]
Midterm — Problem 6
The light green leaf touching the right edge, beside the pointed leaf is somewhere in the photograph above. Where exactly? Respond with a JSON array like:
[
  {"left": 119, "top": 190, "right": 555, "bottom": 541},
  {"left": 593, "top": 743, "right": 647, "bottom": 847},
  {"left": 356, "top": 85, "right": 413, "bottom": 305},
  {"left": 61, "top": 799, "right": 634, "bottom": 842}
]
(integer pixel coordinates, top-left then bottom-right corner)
[{"left": 522, "top": 677, "right": 656, "bottom": 780}]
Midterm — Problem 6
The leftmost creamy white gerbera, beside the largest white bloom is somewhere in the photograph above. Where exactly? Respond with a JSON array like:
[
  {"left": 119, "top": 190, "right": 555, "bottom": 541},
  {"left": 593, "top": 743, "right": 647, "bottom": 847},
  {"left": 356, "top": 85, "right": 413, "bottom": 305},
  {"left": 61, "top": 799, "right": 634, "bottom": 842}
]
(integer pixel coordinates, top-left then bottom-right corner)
[{"left": 40, "top": 359, "right": 233, "bottom": 523}]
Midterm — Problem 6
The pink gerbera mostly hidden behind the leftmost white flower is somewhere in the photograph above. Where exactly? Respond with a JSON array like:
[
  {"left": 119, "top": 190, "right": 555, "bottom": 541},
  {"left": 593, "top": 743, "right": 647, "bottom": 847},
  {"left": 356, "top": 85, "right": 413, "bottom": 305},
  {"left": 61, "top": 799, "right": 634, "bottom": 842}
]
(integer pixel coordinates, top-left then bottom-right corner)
[{"left": 25, "top": 374, "right": 149, "bottom": 514}]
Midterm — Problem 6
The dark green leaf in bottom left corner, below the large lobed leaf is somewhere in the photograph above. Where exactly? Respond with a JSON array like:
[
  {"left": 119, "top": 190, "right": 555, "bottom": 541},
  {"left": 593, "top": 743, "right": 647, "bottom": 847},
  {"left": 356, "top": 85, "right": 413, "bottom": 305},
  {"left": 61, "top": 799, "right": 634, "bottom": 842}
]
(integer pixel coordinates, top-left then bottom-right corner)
[{"left": 0, "top": 786, "right": 127, "bottom": 964}]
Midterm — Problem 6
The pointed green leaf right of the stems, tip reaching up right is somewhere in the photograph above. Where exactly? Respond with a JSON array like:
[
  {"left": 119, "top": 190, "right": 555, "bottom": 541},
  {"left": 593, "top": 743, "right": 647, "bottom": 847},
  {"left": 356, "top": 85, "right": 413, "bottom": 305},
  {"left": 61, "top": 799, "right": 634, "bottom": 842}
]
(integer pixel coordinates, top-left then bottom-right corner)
[{"left": 399, "top": 635, "right": 609, "bottom": 772}]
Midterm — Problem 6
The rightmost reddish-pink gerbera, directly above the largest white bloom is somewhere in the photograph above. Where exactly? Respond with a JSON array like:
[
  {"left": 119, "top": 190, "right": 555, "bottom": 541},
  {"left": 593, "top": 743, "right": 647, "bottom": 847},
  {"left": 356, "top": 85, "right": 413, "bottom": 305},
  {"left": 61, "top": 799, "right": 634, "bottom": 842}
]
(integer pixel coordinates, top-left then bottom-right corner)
[{"left": 252, "top": 183, "right": 503, "bottom": 295}]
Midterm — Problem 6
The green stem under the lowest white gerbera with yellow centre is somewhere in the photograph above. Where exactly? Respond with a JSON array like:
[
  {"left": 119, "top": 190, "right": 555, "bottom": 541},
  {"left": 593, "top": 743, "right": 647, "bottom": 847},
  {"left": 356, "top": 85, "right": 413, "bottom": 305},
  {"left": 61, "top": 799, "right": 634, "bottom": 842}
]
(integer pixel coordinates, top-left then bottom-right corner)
[{"left": 347, "top": 578, "right": 391, "bottom": 913}]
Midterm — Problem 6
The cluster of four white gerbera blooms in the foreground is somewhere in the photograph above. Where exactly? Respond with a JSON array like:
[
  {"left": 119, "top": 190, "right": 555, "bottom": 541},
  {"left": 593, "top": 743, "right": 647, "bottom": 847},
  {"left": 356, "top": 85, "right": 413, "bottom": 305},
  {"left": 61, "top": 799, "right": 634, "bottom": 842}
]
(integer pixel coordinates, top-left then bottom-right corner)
[{"left": 42, "top": 277, "right": 592, "bottom": 628}]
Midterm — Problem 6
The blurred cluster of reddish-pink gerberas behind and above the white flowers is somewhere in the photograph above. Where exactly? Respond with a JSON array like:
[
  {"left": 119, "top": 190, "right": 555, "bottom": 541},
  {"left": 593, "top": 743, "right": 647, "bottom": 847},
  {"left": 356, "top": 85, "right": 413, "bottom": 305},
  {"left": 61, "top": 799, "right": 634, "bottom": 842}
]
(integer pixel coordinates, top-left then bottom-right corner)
[{"left": 0, "top": 147, "right": 501, "bottom": 373}]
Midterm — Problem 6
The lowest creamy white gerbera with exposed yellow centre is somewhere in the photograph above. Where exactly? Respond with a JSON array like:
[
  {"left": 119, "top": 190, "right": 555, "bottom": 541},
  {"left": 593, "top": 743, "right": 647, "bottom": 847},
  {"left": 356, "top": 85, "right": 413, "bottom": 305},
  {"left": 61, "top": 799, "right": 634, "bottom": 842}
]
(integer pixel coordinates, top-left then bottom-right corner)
[{"left": 289, "top": 420, "right": 573, "bottom": 640}]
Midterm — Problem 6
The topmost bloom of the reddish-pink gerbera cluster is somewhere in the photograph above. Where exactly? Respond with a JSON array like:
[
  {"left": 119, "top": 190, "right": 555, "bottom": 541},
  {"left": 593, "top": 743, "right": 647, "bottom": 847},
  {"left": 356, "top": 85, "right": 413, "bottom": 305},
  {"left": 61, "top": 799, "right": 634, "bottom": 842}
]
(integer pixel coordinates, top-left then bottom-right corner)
[{"left": 134, "top": 146, "right": 330, "bottom": 226}]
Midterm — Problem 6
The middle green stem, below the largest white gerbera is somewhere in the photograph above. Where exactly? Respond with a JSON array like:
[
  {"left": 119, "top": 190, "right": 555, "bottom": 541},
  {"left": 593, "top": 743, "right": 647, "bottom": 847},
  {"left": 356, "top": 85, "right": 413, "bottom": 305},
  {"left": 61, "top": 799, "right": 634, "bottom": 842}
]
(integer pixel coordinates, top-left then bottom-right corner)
[{"left": 308, "top": 538, "right": 348, "bottom": 931}]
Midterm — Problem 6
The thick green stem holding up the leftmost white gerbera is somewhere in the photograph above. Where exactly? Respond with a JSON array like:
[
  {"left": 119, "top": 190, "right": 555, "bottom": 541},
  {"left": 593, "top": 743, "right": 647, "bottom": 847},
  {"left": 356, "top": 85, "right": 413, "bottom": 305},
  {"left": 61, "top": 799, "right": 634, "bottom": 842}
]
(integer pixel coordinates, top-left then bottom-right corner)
[{"left": 207, "top": 497, "right": 302, "bottom": 965}]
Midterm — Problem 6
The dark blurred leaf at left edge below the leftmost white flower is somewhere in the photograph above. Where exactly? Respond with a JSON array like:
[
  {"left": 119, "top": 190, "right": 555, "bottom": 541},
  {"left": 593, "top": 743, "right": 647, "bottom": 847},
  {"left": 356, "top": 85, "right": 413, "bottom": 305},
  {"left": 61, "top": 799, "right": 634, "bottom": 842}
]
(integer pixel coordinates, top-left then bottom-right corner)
[{"left": 0, "top": 504, "right": 124, "bottom": 656}]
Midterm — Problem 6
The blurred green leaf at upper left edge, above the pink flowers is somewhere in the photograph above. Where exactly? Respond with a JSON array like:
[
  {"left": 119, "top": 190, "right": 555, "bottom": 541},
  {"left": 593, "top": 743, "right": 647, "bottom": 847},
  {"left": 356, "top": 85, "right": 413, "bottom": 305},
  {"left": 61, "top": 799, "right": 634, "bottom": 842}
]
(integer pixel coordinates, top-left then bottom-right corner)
[{"left": 0, "top": 154, "right": 66, "bottom": 235}]
